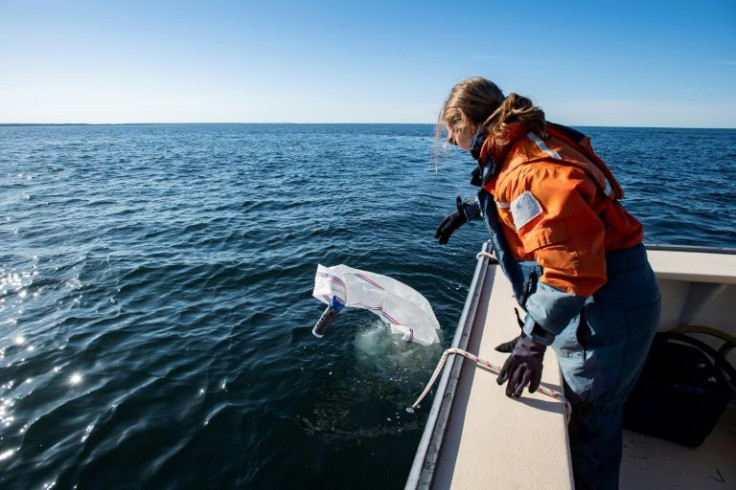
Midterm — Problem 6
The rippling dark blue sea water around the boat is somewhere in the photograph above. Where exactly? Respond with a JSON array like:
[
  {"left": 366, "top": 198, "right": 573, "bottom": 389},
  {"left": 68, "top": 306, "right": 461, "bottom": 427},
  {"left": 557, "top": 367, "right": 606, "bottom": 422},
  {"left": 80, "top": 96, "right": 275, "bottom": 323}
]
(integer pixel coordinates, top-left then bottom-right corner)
[{"left": 0, "top": 124, "right": 736, "bottom": 489}]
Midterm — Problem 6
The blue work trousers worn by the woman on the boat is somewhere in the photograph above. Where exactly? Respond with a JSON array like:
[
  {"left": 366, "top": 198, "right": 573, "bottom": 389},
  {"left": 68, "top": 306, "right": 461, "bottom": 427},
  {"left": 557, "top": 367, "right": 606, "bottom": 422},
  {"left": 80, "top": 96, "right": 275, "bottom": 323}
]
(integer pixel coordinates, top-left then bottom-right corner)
[{"left": 552, "top": 245, "right": 660, "bottom": 489}]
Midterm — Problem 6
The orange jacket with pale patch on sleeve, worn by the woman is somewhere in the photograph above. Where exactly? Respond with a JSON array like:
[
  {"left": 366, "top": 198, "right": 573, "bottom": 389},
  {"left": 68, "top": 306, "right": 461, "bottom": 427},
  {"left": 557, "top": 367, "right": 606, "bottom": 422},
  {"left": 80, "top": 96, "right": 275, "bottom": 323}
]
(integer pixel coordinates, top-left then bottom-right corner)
[{"left": 483, "top": 132, "right": 644, "bottom": 297}]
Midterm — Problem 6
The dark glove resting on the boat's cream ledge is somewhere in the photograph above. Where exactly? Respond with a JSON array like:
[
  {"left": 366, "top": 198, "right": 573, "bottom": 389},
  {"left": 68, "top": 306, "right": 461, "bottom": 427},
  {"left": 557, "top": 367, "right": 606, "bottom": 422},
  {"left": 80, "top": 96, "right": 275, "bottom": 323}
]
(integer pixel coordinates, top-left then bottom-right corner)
[{"left": 496, "top": 336, "right": 547, "bottom": 398}]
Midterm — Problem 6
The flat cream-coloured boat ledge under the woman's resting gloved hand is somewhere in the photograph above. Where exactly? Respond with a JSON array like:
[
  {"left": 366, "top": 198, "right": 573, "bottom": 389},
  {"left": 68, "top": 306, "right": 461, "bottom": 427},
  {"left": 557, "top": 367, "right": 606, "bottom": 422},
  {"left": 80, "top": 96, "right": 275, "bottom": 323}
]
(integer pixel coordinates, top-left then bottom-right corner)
[{"left": 432, "top": 266, "right": 572, "bottom": 490}]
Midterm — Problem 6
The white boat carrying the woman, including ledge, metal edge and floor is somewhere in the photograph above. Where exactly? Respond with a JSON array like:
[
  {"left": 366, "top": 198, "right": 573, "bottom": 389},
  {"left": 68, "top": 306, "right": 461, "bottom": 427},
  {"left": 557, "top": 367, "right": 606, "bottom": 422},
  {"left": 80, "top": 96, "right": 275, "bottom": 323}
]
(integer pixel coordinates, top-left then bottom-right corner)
[{"left": 406, "top": 243, "right": 736, "bottom": 489}]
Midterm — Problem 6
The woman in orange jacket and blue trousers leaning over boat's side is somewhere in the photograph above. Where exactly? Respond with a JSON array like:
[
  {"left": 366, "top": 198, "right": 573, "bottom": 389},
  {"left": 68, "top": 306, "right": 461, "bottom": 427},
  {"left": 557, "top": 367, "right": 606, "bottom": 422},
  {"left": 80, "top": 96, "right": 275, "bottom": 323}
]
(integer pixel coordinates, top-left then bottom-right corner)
[{"left": 435, "top": 77, "right": 660, "bottom": 488}]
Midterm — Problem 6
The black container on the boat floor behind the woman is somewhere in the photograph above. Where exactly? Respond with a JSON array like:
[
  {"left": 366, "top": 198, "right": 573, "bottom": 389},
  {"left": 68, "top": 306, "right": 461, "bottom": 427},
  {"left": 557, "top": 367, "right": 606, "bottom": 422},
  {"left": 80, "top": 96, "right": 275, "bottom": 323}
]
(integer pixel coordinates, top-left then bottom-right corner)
[{"left": 623, "top": 332, "right": 736, "bottom": 447}]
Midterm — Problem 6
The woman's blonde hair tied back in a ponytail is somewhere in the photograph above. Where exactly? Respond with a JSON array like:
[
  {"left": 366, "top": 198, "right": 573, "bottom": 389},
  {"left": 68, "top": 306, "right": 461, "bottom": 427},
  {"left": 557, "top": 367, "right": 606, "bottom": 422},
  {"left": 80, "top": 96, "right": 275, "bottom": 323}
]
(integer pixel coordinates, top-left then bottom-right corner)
[{"left": 435, "top": 77, "right": 546, "bottom": 145}]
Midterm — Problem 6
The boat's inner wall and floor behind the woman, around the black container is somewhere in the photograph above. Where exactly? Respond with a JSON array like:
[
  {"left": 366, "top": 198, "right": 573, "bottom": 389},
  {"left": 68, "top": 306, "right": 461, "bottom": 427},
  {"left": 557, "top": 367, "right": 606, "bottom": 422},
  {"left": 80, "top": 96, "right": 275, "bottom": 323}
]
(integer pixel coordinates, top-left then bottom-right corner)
[{"left": 620, "top": 247, "right": 736, "bottom": 490}]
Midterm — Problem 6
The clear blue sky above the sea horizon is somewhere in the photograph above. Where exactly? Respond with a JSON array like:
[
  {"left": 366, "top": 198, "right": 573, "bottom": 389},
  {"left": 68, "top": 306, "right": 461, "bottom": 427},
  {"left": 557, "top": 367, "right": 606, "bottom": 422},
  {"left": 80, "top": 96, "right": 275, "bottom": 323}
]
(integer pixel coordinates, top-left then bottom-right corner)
[{"left": 0, "top": 0, "right": 736, "bottom": 128}]
